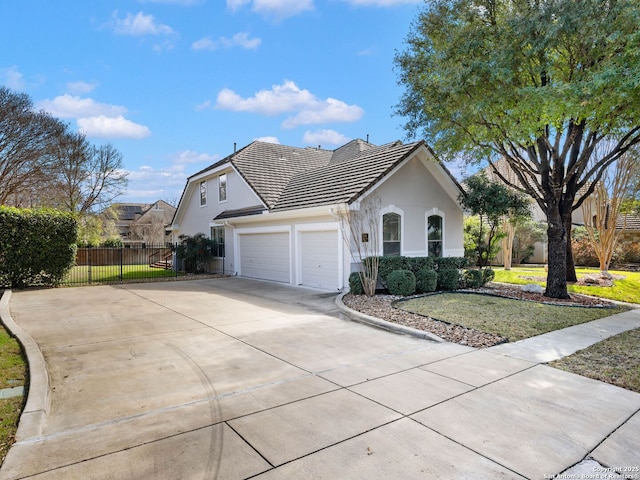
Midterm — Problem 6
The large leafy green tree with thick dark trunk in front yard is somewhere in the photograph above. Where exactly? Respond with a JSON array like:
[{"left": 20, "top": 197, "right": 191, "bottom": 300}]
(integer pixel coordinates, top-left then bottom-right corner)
[{"left": 395, "top": 0, "right": 640, "bottom": 298}]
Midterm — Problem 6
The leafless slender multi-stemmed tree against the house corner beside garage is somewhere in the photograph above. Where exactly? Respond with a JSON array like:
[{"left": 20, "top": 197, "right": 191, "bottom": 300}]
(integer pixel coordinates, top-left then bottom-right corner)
[{"left": 338, "top": 197, "right": 380, "bottom": 297}]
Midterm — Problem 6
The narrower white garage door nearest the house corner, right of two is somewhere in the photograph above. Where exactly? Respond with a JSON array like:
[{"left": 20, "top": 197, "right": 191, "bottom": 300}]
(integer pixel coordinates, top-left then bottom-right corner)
[{"left": 300, "top": 230, "right": 339, "bottom": 290}]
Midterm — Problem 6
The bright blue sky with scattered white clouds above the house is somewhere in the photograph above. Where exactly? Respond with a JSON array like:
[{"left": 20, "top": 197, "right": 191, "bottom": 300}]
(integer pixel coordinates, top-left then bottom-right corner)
[{"left": 0, "top": 0, "right": 460, "bottom": 203}]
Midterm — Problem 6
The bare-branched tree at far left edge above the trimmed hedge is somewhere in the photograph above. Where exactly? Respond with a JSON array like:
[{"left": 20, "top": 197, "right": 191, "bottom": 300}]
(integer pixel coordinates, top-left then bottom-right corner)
[{"left": 0, "top": 87, "right": 67, "bottom": 206}]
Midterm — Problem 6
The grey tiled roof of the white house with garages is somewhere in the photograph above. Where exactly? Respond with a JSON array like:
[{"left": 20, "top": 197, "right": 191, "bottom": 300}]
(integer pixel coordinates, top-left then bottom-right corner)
[{"left": 189, "top": 139, "right": 460, "bottom": 219}]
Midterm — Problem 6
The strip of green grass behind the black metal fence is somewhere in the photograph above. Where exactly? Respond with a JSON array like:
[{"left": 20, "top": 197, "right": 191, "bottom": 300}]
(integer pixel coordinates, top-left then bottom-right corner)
[{"left": 62, "top": 265, "right": 182, "bottom": 285}]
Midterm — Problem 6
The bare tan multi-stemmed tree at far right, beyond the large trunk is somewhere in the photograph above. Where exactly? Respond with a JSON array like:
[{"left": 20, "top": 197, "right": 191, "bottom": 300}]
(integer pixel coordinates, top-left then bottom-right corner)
[{"left": 582, "top": 148, "right": 640, "bottom": 273}]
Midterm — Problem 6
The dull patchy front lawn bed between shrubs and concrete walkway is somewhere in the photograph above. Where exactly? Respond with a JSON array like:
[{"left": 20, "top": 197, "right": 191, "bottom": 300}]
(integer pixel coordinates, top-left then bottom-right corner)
[{"left": 395, "top": 293, "right": 628, "bottom": 342}]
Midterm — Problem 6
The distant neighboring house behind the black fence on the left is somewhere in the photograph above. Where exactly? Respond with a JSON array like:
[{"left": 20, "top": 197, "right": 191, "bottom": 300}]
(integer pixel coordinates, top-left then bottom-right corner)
[{"left": 113, "top": 200, "right": 176, "bottom": 245}]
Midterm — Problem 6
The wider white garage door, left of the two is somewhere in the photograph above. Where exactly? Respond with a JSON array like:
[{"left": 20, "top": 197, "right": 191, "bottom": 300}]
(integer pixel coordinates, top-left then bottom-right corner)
[{"left": 239, "top": 232, "right": 291, "bottom": 283}]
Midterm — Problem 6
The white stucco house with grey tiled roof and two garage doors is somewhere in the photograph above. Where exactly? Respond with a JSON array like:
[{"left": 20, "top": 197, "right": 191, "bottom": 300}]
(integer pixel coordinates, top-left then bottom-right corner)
[{"left": 172, "top": 140, "right": 464, "bottom": 290}]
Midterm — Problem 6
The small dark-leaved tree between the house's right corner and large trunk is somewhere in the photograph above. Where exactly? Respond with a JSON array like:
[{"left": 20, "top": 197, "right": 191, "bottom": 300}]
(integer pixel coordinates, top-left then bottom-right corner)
[{"left": 459, "top": 174, "right": 531, "bottom": 268}]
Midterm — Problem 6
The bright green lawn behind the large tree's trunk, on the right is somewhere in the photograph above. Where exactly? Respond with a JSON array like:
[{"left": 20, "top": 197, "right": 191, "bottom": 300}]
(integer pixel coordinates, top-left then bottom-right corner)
[{"left": 494, "top": 267, "right": 640, "bottom": 304}]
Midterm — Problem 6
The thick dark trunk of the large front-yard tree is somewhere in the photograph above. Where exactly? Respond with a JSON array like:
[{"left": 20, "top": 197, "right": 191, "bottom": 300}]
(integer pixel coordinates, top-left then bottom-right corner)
[{"left": 544, "top": 212, "right": 570, "bottom": 298}]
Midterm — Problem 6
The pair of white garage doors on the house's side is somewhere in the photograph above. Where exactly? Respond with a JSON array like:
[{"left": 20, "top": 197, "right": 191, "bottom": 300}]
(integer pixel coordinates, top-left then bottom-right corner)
[{"left": 238, "top": 230, "right": 340, "bottom": 290}]
